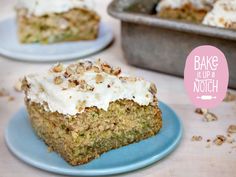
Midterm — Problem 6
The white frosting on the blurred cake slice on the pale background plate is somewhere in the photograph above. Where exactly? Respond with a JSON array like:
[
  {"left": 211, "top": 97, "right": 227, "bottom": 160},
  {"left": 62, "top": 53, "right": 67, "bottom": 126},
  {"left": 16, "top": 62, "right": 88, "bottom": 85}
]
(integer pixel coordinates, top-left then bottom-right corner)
[{"left": 17, "top": 0, "right": 94, "bottom": 16}]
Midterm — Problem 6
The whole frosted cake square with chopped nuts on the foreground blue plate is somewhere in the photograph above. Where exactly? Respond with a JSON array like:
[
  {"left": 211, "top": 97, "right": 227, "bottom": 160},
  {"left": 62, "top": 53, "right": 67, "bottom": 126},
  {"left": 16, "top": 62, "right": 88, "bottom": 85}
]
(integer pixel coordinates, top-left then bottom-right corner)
[{"left": 22, "top": 60, "right": 162, "bottom": 165}]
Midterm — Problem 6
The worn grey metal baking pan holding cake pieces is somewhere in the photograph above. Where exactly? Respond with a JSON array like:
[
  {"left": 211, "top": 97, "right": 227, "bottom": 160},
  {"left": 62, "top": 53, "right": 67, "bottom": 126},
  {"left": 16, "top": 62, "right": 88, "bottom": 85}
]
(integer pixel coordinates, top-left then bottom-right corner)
[{"left": 108, "top": 0, "right": 236, "bottom": 89}]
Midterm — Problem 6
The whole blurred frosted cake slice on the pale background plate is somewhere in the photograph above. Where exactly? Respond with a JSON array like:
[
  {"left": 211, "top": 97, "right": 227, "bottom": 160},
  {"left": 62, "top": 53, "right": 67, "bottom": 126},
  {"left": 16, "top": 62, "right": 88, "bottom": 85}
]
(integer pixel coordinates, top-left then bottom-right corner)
[{"left": 16, "top": 0, "right": 100, "bottom": 44}]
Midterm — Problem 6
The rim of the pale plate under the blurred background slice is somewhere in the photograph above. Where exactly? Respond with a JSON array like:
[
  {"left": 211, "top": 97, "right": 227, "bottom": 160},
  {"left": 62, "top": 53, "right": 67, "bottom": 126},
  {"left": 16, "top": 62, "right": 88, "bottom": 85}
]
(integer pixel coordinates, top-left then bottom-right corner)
[{"left": 0, "top": 17, "right": 115, "bottom": 62}]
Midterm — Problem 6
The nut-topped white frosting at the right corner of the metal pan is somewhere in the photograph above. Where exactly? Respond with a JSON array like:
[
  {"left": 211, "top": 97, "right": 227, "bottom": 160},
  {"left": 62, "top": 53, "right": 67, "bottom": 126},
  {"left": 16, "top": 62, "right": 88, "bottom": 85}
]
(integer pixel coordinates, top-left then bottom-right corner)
[{"left": 203, "top": 0, "right": 236, "bottom": 28}]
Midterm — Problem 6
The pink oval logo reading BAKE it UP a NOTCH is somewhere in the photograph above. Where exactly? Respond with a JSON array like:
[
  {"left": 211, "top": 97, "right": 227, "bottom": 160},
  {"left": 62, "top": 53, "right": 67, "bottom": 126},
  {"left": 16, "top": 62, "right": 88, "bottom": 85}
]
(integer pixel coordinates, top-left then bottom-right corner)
[{"left": 184, "top": 45, "right": 229, "bottom": 108}]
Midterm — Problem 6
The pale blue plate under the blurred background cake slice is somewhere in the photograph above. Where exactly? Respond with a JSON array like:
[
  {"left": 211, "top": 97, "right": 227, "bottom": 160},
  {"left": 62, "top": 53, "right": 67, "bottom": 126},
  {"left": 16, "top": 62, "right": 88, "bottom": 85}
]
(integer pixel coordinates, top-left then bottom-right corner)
[{"left": 0, "top": 18, "right": 113, "bottom": 62}]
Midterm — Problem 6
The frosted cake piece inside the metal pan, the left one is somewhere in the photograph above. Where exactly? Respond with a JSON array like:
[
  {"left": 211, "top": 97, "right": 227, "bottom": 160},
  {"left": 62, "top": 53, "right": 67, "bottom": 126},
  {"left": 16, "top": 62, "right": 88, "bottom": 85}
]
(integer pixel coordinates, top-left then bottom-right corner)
[{"left": 156, "top": 0, "right": 216, "bottom": 23}]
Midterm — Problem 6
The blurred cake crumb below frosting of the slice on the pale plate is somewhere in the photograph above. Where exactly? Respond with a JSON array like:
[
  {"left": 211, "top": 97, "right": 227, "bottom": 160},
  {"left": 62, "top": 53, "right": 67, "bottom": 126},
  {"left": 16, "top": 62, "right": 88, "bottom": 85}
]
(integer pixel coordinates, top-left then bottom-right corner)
[{"left": 17, "top": 8, "right": 100, "bottom": 43}]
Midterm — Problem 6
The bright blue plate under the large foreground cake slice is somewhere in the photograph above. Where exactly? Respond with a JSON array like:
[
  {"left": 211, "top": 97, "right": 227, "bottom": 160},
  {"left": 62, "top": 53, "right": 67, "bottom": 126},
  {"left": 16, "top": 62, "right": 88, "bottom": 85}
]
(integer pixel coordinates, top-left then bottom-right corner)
[{"left": 5, "top": 102, "right": 182, "bottom": 176}]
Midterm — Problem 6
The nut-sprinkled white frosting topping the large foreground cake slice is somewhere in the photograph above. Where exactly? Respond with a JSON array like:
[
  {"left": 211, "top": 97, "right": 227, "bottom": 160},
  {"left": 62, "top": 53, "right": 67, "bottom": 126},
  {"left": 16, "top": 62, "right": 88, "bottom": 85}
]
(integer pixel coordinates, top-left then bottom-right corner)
[{"left": 26, "top": 61, "right": 155, "bottom": 115}]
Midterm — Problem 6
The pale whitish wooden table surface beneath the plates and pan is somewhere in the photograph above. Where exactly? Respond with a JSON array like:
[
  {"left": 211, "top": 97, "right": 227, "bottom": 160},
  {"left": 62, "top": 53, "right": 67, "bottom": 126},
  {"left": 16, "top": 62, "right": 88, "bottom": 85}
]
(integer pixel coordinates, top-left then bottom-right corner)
[{"left": 0, "top": 0, "right": 236, "bottom": 177}]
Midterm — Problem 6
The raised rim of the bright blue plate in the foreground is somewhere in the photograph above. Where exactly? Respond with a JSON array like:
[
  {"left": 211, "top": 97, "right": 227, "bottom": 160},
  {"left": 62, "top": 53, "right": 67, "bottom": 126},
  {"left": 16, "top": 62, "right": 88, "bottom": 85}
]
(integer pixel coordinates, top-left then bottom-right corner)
[{"left": 4, "top": 101, "right": 183, "bottom": 176}]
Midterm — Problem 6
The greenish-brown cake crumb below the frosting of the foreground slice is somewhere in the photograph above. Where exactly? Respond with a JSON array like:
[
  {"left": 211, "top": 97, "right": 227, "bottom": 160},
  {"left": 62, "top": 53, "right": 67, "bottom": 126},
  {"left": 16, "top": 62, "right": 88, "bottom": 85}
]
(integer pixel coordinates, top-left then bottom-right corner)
[{"left": 26, "top": 100, "right": 162, "bottom": 165}]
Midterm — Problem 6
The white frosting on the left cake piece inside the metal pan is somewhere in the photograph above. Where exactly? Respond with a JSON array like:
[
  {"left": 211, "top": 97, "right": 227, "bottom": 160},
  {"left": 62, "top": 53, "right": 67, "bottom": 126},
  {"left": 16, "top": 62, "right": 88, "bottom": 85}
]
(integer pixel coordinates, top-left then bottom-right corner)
[{"left": 156, "top": 0, "right": 216, "bottom": 12}]
